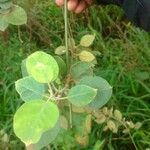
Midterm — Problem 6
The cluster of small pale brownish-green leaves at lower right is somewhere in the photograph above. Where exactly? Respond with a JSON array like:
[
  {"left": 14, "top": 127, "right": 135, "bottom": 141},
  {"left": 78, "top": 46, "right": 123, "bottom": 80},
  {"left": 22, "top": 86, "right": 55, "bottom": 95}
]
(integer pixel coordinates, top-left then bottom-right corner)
[{"left": 93, "top": 107, "right": 142, "bottom": 134}]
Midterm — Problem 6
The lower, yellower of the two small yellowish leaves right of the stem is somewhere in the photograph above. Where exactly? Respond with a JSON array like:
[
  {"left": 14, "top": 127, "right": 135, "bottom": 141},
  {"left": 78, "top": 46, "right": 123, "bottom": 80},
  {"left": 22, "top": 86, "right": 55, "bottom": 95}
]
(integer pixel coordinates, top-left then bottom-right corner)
[{"left": 79, "top": 51, "right": 95, "bottom": 62}]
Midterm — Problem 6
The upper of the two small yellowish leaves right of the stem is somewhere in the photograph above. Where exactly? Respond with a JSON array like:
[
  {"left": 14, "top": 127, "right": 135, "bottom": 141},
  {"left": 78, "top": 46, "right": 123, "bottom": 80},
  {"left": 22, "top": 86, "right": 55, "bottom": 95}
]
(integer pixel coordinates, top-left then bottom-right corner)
[{"left": 80, "top": 34, "right": 95, "bottom": 47}]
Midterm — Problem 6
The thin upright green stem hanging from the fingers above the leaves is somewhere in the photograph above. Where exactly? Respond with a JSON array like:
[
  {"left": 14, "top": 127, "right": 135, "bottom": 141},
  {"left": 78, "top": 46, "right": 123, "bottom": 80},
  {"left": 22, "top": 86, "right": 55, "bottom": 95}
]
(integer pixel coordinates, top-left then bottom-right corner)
[{"left": 64, "top": 0, "right": 69, "bottom": 70}]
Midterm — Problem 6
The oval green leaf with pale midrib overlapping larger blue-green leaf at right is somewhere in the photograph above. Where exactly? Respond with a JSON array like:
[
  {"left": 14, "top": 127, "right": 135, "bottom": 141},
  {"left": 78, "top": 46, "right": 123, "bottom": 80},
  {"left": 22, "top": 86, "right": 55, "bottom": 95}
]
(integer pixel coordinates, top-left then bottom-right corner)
[{"left": 68, "top": 85, "right": 97, "bottom": 106}]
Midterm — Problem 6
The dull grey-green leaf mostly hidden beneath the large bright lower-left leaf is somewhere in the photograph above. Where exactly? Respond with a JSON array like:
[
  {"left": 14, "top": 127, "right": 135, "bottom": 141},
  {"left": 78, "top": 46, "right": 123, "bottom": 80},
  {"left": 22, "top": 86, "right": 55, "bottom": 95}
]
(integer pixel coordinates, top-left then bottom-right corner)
[{"left": 32, "top": 121, "right": 60, "bottom": 150}]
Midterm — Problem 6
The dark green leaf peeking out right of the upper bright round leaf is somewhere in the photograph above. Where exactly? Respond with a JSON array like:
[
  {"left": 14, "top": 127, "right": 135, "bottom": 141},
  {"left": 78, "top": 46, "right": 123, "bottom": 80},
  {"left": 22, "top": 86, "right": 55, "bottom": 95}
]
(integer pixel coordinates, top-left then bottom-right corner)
[{"left": 54, "top": 56, "right": 67, "bottom": 76}]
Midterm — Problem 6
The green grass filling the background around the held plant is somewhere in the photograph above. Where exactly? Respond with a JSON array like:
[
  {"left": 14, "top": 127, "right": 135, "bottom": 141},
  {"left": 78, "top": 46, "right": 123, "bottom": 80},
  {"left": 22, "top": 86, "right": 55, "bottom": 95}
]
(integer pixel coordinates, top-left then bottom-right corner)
[{"left": 0, "top": 1, "right": 150, "bottom": 150}]
